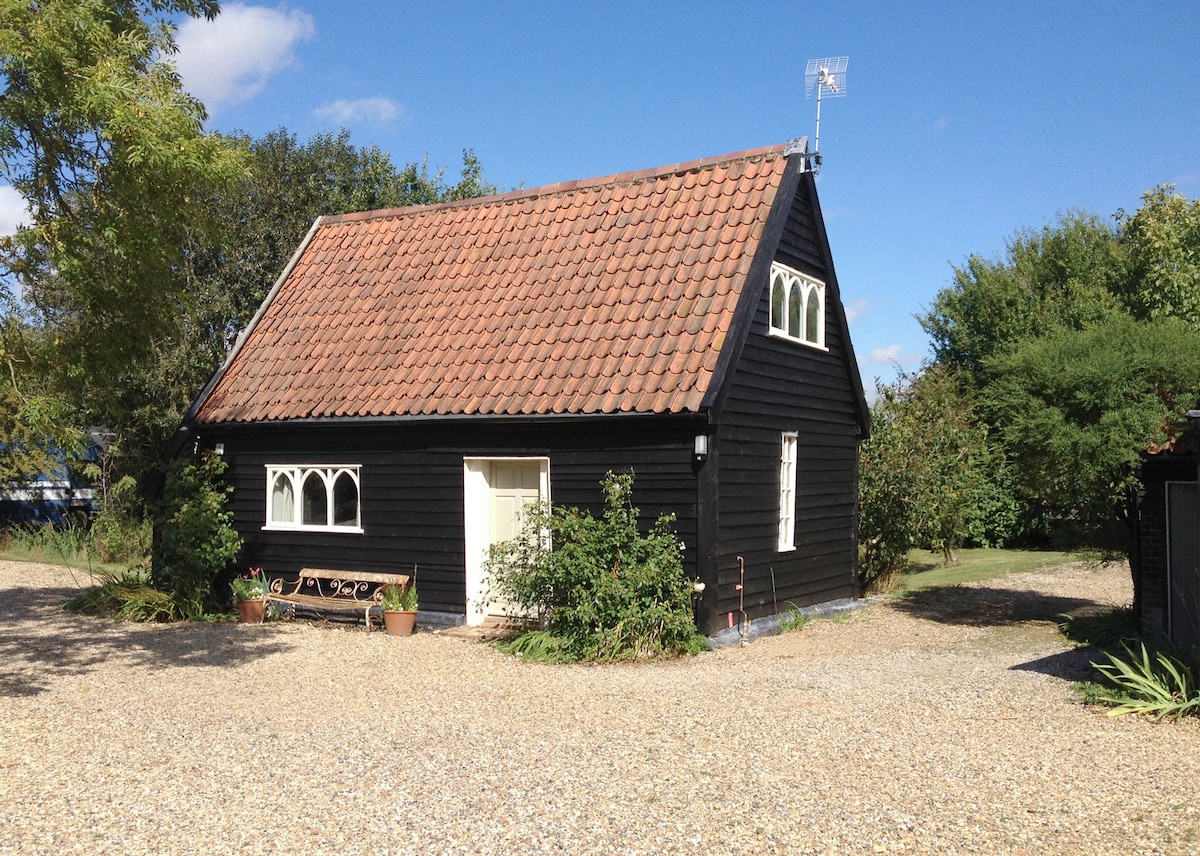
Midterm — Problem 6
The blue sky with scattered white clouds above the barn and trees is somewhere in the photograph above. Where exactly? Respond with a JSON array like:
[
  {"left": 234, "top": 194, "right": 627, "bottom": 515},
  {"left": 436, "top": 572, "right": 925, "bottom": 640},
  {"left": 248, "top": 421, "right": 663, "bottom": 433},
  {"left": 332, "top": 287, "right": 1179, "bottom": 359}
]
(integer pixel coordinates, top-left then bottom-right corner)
[{"left": 145, "top": 0, "right": 1200, "bottom": 389}]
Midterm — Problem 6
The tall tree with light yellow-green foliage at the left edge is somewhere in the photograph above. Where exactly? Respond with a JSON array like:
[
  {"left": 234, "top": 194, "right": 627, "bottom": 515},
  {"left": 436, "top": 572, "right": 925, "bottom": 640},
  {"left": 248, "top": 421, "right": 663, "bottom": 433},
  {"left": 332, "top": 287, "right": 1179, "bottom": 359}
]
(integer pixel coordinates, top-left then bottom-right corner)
[{"left": 0, "top": 0, "right": 242, "bottom": 487}]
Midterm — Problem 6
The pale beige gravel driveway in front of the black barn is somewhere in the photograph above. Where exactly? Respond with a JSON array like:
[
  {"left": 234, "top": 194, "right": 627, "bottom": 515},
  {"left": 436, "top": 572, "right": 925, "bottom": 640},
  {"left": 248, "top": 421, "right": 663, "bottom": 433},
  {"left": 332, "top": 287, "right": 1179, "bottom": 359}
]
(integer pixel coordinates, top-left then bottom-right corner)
[{"left": 0, "top": 563, "right": 1200, "bottom": 854}]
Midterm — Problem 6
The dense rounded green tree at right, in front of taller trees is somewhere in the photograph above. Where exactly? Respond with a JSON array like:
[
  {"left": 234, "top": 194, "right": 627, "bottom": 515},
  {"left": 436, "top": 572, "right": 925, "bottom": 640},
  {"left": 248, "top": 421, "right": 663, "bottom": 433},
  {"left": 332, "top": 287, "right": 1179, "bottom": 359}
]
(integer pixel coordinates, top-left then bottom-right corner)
[{"left": 983, "top": 316, "right": 1200, "bottom": 546}]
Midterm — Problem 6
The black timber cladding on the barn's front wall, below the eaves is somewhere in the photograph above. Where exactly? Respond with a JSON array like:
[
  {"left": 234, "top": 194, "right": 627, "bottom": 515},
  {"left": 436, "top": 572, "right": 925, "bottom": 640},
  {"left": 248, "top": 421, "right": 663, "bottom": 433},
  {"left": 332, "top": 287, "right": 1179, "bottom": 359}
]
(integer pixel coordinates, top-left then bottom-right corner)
[{"left": 202, "top": 418, "right": 697, "bottom": 613}]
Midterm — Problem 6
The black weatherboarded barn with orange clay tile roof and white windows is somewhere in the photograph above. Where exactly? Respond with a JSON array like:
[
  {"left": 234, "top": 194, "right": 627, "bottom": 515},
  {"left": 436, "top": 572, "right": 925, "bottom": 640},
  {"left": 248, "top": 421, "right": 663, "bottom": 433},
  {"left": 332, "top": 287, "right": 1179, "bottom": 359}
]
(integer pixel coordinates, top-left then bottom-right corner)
[{"left": 184, "top": 145, "right": 869, "bottom": 634}]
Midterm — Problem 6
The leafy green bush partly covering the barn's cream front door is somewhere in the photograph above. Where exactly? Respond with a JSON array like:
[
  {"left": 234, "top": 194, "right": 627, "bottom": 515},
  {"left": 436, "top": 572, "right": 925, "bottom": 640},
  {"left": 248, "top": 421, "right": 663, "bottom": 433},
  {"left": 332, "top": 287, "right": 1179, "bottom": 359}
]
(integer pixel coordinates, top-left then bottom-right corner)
[{"left": 477, "top": 472, "right": 703, "bottom": 662}]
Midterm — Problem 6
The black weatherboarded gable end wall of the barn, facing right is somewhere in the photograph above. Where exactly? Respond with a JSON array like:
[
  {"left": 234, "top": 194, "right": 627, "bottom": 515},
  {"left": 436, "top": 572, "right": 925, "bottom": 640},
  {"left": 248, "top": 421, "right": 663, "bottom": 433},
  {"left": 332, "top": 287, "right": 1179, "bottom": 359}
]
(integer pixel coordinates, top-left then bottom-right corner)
[{"left": 715, "top": 171, "right": 859, "bottom": 624}]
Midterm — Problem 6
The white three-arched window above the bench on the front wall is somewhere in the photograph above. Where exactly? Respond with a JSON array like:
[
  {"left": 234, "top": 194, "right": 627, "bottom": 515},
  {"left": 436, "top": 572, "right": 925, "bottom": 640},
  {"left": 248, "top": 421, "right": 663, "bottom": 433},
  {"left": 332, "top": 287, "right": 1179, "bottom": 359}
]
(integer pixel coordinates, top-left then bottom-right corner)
[{"left": 263, "top": 463, "right": 362, "bottom": 532}]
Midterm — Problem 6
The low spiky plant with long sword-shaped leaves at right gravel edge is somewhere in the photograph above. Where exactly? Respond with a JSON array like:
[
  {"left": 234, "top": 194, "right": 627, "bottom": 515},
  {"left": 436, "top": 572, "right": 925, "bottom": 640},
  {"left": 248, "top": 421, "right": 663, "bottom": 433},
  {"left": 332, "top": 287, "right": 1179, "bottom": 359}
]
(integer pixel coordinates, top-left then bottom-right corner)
[{"left": 1092, "top": 642, "right": 1200, "bottom": 719}]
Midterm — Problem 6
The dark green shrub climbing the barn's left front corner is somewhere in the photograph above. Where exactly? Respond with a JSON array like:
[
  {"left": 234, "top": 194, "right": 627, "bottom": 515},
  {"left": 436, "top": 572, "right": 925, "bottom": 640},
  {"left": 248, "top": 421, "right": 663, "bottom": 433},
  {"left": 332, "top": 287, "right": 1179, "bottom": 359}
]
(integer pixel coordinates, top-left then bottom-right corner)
[{"left": 151, "top": 455, "right": 241, "bottom": 618}]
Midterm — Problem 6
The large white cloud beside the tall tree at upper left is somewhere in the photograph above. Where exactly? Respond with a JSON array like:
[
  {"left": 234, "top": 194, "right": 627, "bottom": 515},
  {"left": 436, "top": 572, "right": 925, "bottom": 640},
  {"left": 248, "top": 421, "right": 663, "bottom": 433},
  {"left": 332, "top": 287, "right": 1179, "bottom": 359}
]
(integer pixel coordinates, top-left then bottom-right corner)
[{"left": 175, "top": 4, "right": 317, "bottom": 110}]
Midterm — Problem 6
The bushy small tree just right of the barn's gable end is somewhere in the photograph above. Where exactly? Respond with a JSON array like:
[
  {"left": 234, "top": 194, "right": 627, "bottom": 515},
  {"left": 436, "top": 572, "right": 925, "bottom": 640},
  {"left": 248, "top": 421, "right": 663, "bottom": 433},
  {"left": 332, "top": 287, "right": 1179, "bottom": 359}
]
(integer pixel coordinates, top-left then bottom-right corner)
[{"left": 859, "top": 365, "right": 1018, "bottom": 591}]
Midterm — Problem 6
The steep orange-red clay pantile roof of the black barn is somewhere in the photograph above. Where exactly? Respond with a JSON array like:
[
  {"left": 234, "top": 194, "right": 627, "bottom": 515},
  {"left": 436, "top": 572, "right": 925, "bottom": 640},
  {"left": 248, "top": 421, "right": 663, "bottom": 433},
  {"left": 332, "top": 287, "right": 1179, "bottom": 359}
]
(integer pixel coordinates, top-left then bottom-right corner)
[{"left": 194, "top": 146, "right": 786, "bottom": 423}]
